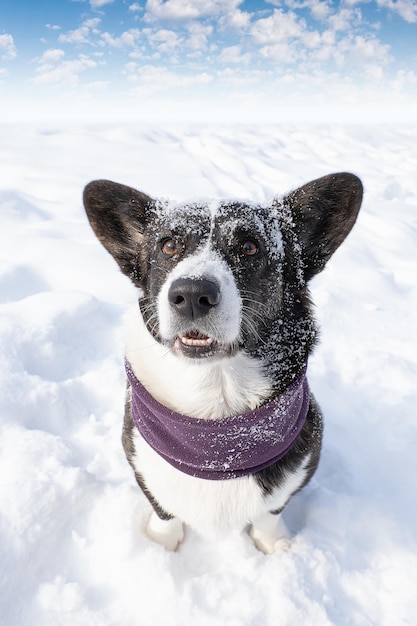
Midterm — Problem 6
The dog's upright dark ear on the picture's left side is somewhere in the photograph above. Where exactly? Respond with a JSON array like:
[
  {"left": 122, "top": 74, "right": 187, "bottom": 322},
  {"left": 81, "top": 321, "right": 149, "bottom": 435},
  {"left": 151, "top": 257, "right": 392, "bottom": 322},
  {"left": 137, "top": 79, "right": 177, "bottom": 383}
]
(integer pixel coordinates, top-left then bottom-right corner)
[{"left": 83, "top": 180, "right": 153, "bottom": 284}]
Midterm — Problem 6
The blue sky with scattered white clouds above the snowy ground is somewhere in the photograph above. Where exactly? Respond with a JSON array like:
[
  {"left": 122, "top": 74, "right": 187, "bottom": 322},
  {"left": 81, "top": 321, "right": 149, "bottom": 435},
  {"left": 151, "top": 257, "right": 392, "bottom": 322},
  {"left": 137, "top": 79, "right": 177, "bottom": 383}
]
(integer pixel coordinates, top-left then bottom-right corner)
[{"left": 0, "top": 0, "right": 417, "bottom": 122}]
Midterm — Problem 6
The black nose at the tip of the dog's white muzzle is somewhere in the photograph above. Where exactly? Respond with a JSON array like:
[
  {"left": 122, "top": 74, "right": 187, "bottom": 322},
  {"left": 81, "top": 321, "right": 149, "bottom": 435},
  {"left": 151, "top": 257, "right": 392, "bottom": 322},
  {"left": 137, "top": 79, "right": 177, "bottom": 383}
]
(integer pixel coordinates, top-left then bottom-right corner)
[{"left": 168, "top": 278, "right": 220, "bottom": 320}]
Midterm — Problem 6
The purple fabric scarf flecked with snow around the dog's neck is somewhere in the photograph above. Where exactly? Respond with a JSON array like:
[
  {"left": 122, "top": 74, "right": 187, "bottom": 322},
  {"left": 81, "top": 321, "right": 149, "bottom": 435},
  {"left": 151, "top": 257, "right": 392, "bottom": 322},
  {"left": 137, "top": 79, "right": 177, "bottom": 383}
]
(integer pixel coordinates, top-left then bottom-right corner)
[{"left": 126, "top": 361, "right": 310, "bottom": 480}]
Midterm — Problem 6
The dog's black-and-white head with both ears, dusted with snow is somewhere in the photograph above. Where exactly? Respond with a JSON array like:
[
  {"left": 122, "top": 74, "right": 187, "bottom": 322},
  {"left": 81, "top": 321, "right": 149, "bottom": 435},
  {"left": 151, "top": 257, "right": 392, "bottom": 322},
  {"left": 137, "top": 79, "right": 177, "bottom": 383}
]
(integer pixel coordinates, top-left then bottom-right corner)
[{"left": 84, "top": 173, "right": 362, "bottom": 380}]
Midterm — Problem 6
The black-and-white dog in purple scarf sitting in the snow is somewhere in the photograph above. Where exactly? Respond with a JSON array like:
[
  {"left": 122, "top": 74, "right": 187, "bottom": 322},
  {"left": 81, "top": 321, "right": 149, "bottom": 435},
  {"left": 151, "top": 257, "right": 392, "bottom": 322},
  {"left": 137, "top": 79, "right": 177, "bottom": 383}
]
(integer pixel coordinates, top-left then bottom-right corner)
[{"left": 84, "top": 173, "right": 363, "bottom": 554}]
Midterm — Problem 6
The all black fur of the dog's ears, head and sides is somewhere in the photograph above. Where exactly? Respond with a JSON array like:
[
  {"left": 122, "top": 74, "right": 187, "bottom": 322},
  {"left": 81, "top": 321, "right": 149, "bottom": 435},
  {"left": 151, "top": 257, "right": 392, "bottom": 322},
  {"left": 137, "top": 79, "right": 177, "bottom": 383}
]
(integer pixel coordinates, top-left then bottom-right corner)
[{"left": 84, "top": 173, "right": 362, "bottom": 532}]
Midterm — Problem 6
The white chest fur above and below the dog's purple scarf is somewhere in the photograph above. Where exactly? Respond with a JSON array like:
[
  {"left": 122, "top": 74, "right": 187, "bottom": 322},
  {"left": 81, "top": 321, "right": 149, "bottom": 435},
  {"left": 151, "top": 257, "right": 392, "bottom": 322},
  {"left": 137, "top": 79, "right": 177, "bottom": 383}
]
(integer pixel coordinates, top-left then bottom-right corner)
[{"left": 126, "top": 308, "right": 306, "bottom": 535}]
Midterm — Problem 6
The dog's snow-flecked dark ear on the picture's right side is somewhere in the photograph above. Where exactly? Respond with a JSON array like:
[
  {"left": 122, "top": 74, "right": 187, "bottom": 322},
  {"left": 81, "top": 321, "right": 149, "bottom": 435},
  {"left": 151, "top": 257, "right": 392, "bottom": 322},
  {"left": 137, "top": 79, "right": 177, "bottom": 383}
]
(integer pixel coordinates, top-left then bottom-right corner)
[{"left": 284, "top": 172, "right": 363, "bottom": 280}]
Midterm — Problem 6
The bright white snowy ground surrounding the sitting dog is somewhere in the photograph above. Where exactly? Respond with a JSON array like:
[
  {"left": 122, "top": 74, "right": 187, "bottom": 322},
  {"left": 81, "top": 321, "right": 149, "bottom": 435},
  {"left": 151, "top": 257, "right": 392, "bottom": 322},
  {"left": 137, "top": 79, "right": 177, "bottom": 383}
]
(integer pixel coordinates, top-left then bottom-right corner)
[{"left": 0, "top": 123, "right": 417, "bottom": 626}]
